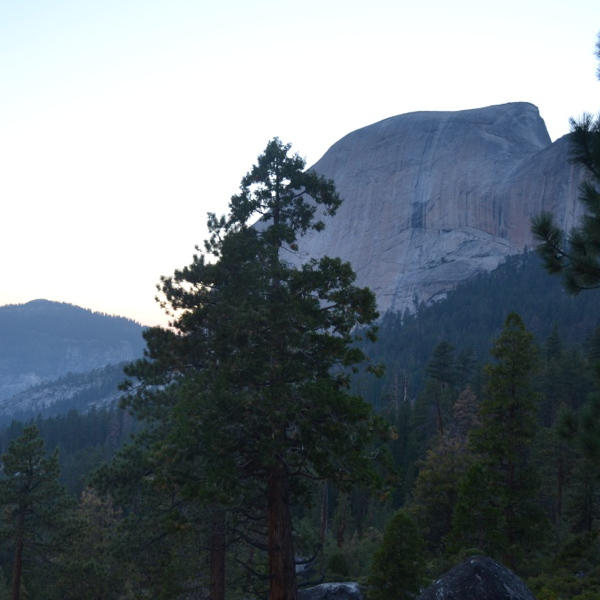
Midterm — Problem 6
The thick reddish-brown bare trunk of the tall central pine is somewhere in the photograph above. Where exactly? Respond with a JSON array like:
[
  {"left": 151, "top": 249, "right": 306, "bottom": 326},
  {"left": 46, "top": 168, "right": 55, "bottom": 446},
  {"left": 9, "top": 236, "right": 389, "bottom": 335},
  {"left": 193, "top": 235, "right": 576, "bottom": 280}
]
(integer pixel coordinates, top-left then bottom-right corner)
[{"left": 267, "top": 462, "right": 298, "bottom": 600}]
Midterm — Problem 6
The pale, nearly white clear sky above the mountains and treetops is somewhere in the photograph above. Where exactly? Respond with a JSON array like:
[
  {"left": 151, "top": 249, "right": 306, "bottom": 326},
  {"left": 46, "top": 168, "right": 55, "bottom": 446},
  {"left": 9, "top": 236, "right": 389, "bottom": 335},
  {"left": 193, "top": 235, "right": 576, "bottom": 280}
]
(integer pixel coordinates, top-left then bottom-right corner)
[{"left": 0, "top": 0, "right": 600, "bottom": 325}]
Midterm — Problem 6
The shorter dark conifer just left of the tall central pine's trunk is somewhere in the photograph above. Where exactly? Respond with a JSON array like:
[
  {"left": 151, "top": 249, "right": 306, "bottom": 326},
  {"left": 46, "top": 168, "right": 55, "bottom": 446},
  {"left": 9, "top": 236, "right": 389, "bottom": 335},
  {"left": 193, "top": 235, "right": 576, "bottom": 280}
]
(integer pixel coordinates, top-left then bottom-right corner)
[{"left": 94, "top": 410, "right": 212, "bottom": 599}]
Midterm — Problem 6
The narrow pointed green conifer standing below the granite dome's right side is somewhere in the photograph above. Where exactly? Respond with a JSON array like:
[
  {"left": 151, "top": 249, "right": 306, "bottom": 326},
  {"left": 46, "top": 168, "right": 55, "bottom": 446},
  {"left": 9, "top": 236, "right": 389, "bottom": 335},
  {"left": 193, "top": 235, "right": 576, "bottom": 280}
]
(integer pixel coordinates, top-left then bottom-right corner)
[{"left": 454, "top": 313, "right": 543, "bottom": 568}]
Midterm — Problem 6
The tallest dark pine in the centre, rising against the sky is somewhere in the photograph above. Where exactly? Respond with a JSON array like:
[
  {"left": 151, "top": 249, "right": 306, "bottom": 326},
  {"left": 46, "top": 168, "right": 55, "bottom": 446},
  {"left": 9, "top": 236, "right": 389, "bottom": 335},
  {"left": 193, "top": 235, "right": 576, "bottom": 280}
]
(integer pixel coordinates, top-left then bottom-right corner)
[{"left": 112, "top": 139, "right": 385, "bottom": 600}]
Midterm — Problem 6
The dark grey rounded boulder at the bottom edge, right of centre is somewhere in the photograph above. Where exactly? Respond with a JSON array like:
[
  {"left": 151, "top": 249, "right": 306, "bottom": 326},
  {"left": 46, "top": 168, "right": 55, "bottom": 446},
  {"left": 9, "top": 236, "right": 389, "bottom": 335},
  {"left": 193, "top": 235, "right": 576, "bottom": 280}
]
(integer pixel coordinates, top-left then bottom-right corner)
[{"left": 417, "top": 556, "right": 535, "bottom": 600}]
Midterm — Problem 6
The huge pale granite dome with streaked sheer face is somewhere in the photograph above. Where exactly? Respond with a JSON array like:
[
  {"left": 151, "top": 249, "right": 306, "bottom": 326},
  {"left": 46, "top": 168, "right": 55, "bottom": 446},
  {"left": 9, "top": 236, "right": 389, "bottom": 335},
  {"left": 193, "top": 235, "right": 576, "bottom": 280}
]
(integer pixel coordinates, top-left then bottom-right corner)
[{"left": 300, "top": 102, "right": 582, "bottom": 312}]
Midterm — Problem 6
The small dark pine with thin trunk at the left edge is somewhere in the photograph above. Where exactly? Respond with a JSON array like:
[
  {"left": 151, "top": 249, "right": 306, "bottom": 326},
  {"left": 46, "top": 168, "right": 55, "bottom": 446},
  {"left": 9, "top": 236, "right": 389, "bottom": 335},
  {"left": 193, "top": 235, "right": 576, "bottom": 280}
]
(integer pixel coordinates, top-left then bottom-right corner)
[{"left": 0, "top": 425, "right": 69, "bottom": 600}]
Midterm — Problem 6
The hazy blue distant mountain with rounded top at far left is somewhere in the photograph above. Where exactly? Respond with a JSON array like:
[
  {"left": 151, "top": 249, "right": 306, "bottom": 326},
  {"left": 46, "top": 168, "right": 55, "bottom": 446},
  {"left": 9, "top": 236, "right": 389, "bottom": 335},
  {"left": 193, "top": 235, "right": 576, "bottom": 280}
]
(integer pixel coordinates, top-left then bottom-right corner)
[{"left": 0, "top": 300, "right": 145, "bottom": 400}]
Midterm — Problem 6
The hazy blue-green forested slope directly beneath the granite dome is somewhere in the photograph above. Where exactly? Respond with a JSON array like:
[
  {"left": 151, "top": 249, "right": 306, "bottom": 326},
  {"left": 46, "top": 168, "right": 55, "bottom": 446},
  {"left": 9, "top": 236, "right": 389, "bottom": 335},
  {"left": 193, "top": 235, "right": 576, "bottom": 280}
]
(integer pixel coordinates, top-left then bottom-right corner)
[{"left": 354, "top": 252, "right": 600, "bottom": 407}]
